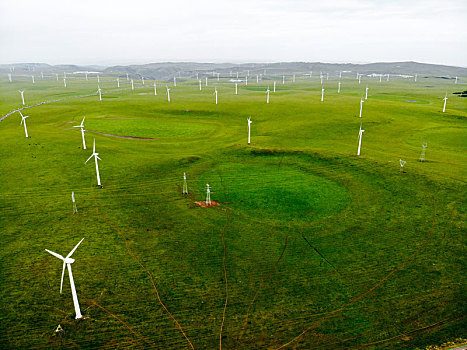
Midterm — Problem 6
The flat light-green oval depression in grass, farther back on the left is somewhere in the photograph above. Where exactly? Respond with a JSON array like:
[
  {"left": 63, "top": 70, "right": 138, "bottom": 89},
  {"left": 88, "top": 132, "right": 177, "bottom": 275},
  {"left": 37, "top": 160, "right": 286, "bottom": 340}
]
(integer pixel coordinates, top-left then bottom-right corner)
[{"left": 86, "top": 116, "right": 217, "bottom": 139}]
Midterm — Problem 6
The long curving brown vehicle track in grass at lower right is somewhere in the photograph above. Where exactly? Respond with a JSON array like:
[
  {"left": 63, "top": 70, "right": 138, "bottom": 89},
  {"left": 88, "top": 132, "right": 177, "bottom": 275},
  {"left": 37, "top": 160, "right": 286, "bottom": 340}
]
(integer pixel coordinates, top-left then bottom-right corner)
[{"left": 271, "top": 194, "right": 438, "bottom": 350}]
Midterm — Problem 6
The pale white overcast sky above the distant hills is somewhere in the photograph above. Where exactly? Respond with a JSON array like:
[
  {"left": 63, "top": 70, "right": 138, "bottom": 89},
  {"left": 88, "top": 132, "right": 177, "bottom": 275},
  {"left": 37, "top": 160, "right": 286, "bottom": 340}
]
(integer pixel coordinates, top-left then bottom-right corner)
[{"left": 0, "top": 0, "right": 467, "bottom": 67}]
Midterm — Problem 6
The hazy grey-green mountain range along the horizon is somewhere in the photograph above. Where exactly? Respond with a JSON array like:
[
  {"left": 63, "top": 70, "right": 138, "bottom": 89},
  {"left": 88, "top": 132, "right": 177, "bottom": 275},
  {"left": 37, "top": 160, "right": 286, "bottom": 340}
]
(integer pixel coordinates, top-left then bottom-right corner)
[{"left": 0, "top": 62, "right": 467, "bottom": 81}]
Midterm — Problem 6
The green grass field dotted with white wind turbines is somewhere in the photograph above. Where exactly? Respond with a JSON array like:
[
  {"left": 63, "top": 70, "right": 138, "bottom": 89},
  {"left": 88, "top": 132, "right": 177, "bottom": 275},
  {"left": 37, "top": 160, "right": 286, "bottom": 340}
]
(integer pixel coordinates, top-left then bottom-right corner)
[{"left": 0, "top": 72, "right": 467, "bottom": 349}]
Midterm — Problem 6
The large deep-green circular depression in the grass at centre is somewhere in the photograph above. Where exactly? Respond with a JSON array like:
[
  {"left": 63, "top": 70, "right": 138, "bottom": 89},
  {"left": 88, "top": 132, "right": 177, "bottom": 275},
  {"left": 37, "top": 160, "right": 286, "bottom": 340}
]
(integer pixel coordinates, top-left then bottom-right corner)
[{"left": 199, "top": 163, "right": 350, "bottom": 221}]
